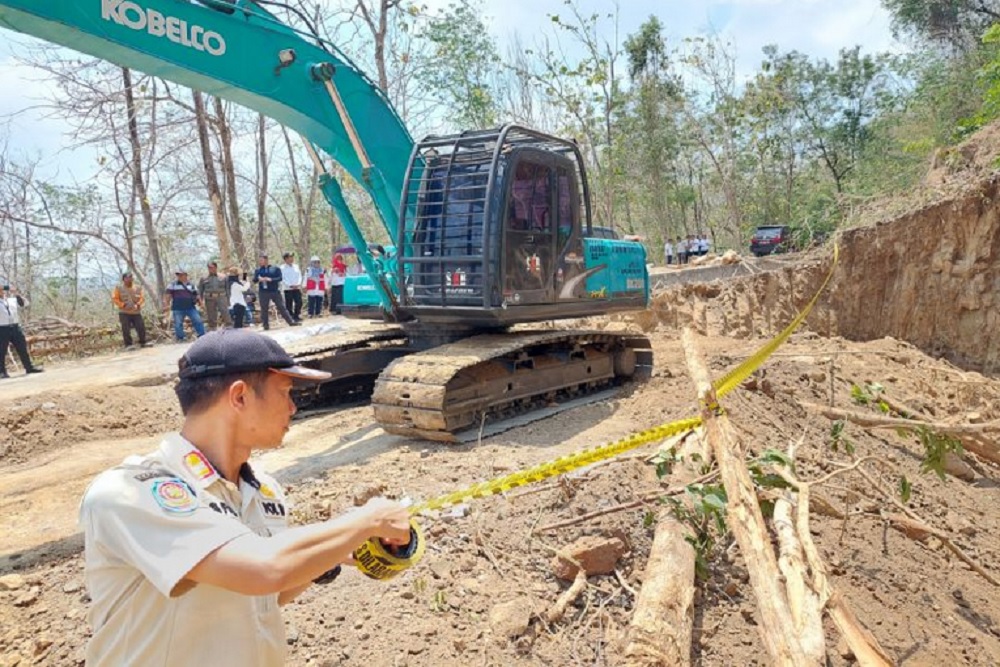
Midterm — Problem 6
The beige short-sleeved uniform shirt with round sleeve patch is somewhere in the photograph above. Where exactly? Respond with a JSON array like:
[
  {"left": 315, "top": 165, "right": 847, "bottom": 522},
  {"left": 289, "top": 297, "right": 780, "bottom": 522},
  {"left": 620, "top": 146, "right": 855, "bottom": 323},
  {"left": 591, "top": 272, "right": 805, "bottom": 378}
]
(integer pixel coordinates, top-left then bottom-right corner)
[{"left": 80, "top": 434, "right": 288, "bottom": 667}]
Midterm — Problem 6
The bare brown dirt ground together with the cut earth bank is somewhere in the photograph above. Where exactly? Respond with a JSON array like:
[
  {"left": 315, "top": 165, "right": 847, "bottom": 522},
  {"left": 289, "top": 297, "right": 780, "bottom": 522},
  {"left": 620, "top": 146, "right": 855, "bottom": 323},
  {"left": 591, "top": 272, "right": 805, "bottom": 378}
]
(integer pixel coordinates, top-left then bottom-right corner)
[{"left": 0, "top": 132, "right": 1000, "bottom": 667}]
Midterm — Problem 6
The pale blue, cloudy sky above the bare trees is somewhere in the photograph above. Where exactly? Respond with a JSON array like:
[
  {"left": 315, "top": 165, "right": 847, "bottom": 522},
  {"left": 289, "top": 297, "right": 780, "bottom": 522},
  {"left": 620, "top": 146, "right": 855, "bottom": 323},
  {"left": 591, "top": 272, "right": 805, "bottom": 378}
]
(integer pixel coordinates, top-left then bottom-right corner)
[{"left": 0, "top": 0, "right": 901, "bottom": 183}]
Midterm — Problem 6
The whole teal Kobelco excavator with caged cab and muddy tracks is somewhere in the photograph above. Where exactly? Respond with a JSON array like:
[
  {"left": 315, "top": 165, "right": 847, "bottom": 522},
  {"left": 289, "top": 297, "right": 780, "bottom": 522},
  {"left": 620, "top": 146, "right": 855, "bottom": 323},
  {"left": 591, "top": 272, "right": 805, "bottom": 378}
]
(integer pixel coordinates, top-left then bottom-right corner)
[{"left": 0, "top": 0, "right": 652, "bottom": 442}]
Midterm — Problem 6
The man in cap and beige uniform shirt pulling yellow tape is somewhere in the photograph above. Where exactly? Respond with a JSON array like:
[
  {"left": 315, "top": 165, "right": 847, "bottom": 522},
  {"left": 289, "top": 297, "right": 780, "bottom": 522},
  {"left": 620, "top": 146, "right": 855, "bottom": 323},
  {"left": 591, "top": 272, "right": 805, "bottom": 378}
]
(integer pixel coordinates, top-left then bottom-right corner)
[{"left": 80, "top": 329, "right": 410, "bottom": 667}]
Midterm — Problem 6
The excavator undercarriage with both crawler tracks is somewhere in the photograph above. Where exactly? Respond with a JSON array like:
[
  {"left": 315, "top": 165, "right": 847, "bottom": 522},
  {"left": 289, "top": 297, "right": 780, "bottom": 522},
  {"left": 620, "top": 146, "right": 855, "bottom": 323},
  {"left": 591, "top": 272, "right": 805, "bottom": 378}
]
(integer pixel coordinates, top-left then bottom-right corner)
[{"left": 289, "top": 327, "right": 653, "bottom": 442}]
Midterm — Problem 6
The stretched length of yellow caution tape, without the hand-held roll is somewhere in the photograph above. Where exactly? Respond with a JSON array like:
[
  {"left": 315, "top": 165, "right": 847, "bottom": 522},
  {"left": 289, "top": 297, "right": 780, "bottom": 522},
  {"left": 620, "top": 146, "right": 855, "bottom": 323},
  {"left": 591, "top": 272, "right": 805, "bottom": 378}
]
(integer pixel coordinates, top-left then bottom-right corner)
[{"left": 410, "top": 244, "right": 840, "bottom": 514}]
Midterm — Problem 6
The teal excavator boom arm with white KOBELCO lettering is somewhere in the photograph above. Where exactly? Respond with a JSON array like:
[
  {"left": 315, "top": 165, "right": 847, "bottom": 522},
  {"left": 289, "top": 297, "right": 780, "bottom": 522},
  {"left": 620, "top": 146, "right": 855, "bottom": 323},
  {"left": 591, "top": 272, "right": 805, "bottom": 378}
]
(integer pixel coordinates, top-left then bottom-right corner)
[{"left": 0, "top": 0, "right": 413, "bottom": 310}]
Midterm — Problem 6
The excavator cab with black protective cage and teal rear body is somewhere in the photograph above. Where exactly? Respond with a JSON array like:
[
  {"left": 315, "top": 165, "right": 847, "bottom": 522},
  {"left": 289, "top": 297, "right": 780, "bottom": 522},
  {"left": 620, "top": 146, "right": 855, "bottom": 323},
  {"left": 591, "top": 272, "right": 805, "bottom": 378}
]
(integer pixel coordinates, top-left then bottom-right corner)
[{"left": 396, "top": 125, "right": 649, "bottom": 327}]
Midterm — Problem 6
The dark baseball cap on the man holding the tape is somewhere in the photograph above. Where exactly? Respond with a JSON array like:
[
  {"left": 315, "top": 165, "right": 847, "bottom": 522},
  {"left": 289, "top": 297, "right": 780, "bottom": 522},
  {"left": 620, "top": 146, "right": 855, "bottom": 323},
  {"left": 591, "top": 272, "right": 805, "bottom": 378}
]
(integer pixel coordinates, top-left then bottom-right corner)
[{"left": 177, "top": 329, "right": 330, "bottom": 382}]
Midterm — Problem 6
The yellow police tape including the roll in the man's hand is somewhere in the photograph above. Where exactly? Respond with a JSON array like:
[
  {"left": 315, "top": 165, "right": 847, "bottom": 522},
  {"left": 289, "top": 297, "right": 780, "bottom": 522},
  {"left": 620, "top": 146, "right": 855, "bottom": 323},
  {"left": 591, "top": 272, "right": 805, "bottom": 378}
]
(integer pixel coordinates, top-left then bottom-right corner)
[{"left": 354, "top": 244, "right": 840, "bottom": 580}]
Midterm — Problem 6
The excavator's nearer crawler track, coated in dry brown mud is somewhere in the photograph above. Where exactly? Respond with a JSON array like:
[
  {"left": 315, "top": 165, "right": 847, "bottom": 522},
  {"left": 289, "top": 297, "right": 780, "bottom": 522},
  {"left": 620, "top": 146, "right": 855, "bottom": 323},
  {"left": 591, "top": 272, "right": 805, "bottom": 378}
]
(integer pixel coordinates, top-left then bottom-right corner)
[{"left": 372, "top": 331, "right": 653, "bottom": 442}]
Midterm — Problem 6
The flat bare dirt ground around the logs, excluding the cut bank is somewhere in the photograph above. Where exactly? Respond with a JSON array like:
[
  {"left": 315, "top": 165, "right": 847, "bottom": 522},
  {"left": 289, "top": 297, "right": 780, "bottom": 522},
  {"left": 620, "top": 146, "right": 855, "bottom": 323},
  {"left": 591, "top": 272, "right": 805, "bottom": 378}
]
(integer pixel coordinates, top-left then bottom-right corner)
[{"left": 0, "top": 310, "right": 1000, "bottom": 666}]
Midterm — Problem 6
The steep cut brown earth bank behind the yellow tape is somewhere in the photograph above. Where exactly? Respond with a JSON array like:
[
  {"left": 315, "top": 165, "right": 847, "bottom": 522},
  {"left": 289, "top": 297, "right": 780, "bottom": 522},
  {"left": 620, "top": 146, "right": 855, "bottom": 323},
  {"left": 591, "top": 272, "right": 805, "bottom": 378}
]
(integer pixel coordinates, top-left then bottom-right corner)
[{"left": 652, "top": 175, "right": 1000, "bottom": 373}]
